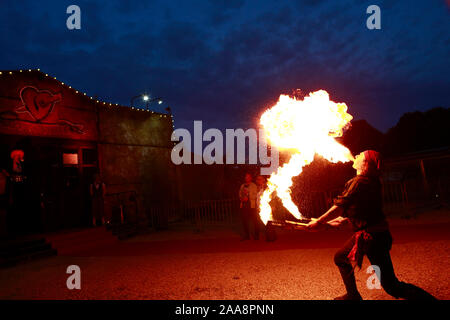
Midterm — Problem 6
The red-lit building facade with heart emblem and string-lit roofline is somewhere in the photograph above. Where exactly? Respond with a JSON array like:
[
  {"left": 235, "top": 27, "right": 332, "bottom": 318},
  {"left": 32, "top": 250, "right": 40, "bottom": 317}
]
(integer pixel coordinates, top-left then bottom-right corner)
[{"left": 0, "top": 70, "right": 177, "bottom": 232}]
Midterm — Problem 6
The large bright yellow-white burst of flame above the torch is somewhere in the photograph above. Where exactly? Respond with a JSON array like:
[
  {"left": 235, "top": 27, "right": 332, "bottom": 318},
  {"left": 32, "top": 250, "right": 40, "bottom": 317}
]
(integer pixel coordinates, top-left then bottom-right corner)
[{"left": 259, "top": 90, "right": 354, "bottom": 224}]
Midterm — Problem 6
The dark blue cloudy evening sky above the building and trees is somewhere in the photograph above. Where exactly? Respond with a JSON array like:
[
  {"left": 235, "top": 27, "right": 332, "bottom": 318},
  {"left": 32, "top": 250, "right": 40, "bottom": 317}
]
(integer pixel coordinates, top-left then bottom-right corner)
[{"left": 0, "top": 0, "right": 450, "bottom": 131}]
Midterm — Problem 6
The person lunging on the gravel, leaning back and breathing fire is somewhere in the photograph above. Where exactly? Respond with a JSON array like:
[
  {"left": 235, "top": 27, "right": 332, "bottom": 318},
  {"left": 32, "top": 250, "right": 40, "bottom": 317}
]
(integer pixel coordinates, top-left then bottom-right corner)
[{"left": 307, "top": 150, "right": 435, "bottom": 300}]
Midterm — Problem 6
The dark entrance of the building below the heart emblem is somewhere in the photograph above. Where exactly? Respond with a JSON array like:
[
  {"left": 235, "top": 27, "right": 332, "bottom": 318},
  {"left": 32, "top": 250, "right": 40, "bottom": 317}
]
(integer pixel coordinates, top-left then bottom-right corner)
[{"left": 0, "top": 135, "right": 98, "bottom": 234}]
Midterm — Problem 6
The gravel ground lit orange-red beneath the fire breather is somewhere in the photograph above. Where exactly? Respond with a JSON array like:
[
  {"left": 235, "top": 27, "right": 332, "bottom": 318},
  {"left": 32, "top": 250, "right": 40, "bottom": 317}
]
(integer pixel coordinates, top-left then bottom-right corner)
[{"left": 0, "top": 218, "right": 450, "bottom": 300}]
